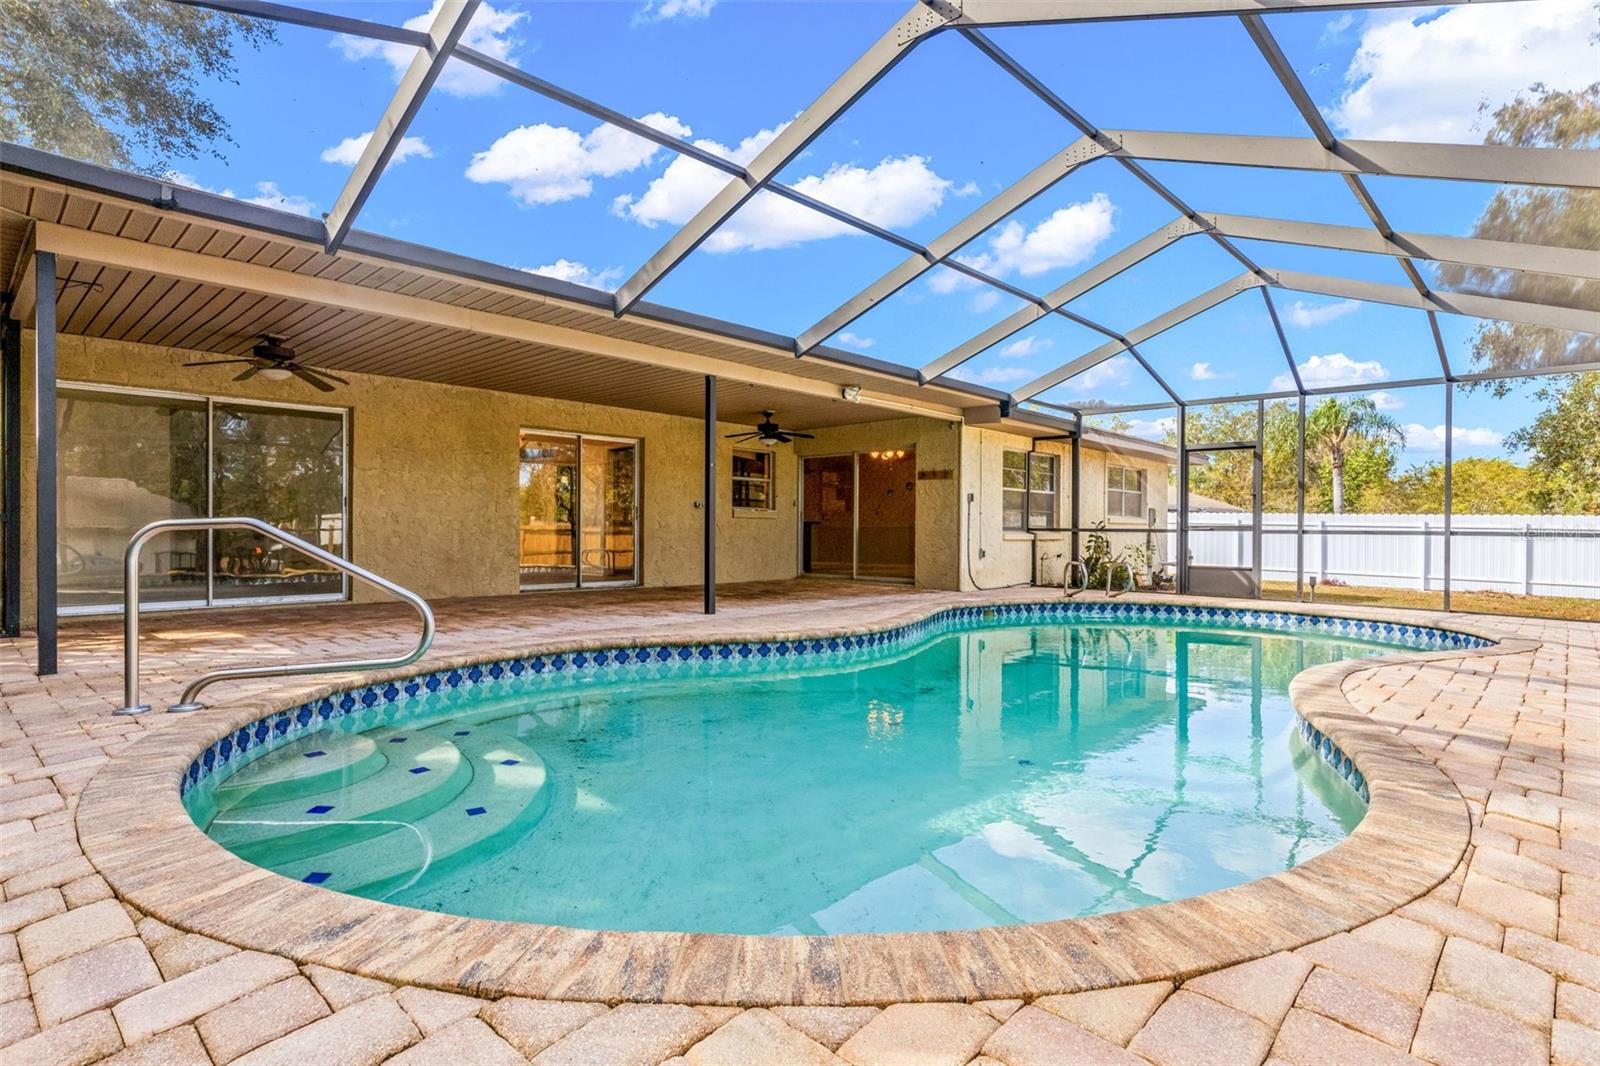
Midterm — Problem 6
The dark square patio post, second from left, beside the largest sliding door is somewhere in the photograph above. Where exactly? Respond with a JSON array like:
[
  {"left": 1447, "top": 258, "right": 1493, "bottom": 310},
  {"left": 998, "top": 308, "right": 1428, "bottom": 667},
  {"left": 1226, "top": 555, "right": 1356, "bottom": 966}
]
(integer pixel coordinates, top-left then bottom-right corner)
[{"left": 34, "top": 251, "right": 56, "bottom": 677}]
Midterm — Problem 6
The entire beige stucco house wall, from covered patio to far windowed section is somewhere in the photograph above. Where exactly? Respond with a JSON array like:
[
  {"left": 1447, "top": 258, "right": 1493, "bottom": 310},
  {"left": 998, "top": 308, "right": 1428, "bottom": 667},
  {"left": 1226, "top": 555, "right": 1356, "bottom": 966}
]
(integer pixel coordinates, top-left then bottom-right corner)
[{"left": 9, "top": 335, "right": 1168, "bottom": 618}]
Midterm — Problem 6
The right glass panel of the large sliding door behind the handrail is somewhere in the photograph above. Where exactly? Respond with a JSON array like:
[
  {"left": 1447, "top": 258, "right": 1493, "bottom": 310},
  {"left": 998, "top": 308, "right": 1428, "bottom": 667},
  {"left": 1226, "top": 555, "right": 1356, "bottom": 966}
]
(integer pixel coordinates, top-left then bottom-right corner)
[{"left": 211, "top": 403, "right": 344, "bottom": 602}]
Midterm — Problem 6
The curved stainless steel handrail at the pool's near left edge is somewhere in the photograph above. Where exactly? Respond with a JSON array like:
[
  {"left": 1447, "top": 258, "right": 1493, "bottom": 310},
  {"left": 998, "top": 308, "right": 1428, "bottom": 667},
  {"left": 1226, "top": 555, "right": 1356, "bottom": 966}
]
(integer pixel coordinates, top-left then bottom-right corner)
[{"left": 117, "top": 517, "right": 434, "bottom": 714}]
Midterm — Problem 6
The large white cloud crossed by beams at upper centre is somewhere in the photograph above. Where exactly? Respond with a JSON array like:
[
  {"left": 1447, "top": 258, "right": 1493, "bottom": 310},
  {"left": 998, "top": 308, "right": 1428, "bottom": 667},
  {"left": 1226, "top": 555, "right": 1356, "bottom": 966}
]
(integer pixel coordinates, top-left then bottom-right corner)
[{"left": 611, "top": 123, "right": 952, "bottom": 251}]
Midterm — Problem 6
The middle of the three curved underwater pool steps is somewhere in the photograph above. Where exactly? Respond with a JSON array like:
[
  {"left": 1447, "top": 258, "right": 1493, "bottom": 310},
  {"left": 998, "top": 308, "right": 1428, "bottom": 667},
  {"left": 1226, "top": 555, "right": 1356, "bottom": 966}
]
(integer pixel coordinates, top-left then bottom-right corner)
[{"left": 208, "top": 728, "right": 472, "bottom": 869}]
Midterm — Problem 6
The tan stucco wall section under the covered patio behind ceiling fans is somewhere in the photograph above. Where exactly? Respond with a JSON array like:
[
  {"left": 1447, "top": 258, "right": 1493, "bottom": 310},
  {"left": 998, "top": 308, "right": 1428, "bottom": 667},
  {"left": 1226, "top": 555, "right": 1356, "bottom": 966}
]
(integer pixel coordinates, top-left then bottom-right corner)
[{"left": 22, "top": 331, "right": 798, "bottom": 616}]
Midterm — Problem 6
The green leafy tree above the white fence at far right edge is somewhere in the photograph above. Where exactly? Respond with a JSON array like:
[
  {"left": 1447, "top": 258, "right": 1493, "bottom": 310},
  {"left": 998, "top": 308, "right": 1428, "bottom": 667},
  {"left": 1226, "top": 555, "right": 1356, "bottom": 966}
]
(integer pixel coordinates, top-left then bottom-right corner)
[{"left": 1507, "top": 371, "right": 1600, "bottom": 514}]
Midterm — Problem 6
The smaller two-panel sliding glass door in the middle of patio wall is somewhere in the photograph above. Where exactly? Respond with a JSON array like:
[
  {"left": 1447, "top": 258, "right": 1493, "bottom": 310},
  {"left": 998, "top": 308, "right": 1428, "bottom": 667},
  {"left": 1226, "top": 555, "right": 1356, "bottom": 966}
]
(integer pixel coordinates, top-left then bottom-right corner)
[{"left": 517, "top": 429, "right": 638, "bottom": 591}]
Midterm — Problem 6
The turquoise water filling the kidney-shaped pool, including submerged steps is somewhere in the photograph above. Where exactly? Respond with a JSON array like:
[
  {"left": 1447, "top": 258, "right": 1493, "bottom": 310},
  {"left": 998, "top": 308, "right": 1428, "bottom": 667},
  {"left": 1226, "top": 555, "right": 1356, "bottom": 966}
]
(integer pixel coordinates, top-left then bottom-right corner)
[{"left": 189, "top": 621, "right": 1392, "bottom": 933}]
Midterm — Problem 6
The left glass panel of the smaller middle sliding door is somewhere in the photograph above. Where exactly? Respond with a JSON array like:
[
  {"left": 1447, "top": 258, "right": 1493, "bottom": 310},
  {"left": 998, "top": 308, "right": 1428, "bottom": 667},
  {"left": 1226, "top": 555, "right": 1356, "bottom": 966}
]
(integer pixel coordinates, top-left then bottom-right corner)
[{"left": 517, "top": 431, "right": 581, "bottom": 589}]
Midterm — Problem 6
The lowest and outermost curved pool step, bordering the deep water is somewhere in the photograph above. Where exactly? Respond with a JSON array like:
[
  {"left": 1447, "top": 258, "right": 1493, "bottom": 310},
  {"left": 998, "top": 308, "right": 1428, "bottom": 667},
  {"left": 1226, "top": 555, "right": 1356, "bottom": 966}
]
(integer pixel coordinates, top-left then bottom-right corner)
[{"left": 256, "top": 722, "right": 550, "bottom": 896}]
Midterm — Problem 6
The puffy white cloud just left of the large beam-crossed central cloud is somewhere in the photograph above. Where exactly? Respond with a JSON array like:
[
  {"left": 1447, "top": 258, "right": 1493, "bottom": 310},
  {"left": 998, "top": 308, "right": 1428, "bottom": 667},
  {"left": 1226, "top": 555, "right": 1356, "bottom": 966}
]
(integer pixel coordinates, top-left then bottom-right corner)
[{"left": 467, "top": 112, "right": 690, "bottom": 203}]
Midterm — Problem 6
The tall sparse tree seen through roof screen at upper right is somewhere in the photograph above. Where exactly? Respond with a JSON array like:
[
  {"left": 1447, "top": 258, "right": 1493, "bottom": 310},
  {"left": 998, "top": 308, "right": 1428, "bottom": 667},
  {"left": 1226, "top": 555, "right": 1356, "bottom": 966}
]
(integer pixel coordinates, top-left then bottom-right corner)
[{"left": 1438, "top": 73, "right": 1600, "bottom": 377}]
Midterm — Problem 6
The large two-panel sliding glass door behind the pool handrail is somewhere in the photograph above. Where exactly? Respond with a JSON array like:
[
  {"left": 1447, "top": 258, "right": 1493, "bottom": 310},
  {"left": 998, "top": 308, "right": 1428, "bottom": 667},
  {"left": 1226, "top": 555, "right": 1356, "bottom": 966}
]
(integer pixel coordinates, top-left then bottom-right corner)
[{"left": 56, "top": 386, "right": 347, "bottom": 615}]
